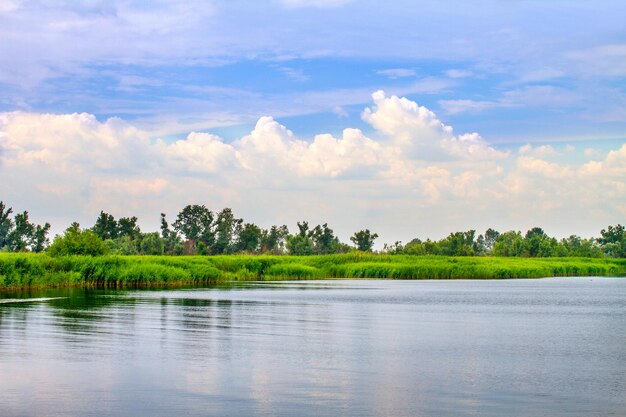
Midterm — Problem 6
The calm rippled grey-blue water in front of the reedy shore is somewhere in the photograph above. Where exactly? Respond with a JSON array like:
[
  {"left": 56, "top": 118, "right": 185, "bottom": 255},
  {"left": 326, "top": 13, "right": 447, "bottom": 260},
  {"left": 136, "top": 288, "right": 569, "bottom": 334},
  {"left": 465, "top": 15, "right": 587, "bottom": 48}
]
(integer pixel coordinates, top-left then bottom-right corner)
[{"left": 0, "top": 278, "right": 626, "bottom": 417}]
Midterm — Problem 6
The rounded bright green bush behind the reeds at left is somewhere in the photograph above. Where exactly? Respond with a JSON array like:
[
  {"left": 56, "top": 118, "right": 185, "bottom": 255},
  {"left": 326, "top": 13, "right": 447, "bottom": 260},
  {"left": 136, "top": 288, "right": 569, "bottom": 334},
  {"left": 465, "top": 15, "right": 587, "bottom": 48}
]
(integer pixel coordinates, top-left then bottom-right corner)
[{"left": 48, "top": 223, "right": 109, "bottom": 256}]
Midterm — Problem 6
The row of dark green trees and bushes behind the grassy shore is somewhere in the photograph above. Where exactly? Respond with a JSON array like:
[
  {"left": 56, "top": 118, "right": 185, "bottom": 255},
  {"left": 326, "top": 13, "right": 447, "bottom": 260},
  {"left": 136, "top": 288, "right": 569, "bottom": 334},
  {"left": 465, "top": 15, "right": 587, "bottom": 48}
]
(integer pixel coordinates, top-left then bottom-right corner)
[{"left": 0, "top": 201, "right": 626, "bottom": 258}]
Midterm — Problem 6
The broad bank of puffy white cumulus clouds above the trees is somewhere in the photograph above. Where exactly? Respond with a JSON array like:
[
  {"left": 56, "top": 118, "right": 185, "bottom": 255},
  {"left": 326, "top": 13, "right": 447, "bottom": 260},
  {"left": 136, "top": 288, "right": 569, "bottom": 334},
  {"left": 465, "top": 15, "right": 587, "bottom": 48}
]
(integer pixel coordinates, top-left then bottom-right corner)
[{"left": 0, "top": 91, "right": 626, "bottom": 241}]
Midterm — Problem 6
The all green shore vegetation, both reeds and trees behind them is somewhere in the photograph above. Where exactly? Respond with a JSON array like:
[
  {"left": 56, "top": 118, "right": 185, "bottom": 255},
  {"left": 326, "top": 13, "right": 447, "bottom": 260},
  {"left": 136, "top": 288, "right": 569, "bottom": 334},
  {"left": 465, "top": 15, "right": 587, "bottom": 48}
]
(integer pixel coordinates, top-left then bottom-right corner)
[{"left": 0, "top": 201, "right": 626, "bottom": 290}]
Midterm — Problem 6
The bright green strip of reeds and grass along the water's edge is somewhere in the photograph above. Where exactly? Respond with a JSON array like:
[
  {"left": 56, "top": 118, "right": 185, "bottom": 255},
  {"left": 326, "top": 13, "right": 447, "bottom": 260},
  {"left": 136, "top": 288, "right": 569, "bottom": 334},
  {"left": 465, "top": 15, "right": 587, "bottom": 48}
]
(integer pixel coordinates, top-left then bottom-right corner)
[{"left": 0, "top": 253, "right": 626, "bottom": 291}]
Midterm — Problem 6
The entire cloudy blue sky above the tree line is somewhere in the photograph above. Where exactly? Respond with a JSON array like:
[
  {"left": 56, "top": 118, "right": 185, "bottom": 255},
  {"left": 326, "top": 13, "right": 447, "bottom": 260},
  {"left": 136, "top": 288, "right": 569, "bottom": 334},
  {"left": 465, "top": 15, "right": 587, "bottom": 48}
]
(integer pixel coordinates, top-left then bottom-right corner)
[{"left": 0, "top": 0, "right": 626, "bottom": 245}]
